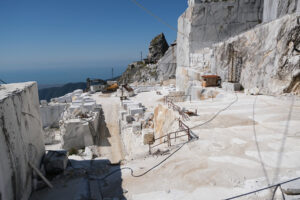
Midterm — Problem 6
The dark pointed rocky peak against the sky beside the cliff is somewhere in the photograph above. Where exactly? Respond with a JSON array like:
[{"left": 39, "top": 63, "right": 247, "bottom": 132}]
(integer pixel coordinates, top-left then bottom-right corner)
[{"left": 148, "top": 33, "right": 169, "bottom": 63}]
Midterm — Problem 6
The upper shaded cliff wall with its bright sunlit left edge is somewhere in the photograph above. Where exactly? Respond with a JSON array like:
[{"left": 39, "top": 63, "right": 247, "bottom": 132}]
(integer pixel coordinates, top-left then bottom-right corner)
[{"left": 176, "top": 0, "right": 263, "bottom": 90}]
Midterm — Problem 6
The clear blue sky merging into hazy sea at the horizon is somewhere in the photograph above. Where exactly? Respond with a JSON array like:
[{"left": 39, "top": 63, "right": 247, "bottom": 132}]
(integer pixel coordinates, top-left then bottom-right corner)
[{"left": 0, "top": 0, "right": 187, "bottom": 83}]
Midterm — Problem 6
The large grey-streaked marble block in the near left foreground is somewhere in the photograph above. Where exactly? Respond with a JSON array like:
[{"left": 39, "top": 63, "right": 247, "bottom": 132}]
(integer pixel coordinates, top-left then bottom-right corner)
[{"left": 0, "top": 82, "right": 45, "bottom": 200}]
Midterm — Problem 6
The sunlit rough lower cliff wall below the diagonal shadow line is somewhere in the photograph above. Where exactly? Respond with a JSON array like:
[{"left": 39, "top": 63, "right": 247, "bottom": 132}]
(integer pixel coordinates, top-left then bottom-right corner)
[{"left": 180, "top": 14, "right": 300, "bottom": 95}]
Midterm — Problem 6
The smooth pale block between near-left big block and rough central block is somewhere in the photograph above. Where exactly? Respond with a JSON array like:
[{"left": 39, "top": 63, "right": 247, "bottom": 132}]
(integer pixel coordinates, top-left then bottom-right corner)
[{"left": 40, "top": 103, "right": 66, "bottom": 128}]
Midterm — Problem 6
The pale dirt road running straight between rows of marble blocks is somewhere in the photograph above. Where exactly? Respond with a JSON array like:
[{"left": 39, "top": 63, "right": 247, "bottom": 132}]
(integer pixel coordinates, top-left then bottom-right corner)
[{"left": 93, "top": 93, "right": 124, "bottom": 164}]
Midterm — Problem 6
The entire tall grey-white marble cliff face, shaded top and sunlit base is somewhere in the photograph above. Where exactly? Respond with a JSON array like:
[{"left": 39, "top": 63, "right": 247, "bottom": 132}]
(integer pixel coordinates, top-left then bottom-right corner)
[{"left": 176, "top": 0, "right": 300, "bottom": 94}]
